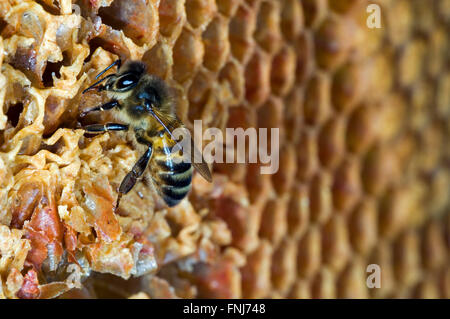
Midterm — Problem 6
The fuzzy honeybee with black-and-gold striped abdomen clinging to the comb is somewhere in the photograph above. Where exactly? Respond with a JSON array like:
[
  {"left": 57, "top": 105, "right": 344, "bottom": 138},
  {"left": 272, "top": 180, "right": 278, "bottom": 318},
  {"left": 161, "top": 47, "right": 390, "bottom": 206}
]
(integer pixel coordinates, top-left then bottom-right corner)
[{"left": 80, "top": 59, "right": 212, "bottom": 210}]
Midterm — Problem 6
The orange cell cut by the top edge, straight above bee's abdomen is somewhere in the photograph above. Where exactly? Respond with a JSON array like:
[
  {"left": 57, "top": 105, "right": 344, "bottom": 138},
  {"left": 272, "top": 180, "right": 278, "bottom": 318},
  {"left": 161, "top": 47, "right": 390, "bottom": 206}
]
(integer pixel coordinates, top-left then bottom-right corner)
[{"left": 159, "top": 0, "right": 186, "bottom": 38}]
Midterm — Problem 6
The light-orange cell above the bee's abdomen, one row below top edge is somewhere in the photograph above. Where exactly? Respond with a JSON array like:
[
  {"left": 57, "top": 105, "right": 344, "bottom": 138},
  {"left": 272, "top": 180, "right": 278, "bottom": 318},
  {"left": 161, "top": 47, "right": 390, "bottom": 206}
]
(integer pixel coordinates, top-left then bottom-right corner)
[{"left": 173, "top": 29, "right": 204, "bottom": 83}]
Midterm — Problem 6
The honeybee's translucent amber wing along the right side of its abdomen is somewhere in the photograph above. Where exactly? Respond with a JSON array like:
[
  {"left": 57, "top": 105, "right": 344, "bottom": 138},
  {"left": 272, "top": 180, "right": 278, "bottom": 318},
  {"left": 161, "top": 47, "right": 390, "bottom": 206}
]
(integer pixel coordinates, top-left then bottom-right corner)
[{"left": 152, "top": 112, "right": 212, "bottom": 182}]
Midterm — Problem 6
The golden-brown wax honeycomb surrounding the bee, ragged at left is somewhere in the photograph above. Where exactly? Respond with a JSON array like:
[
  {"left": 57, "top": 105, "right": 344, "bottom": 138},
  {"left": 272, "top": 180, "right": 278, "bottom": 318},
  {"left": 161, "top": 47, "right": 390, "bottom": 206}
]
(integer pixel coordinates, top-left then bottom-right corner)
[{"left": 0, "top": 0, "right": 450, "bottom": 298}]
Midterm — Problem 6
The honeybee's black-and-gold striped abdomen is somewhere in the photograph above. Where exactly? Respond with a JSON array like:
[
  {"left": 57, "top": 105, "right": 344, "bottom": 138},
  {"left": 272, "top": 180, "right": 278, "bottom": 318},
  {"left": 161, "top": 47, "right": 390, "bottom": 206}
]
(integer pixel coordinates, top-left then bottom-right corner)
[{"left": 149, "top": 134, "right": 193, "bottom": 207}]
